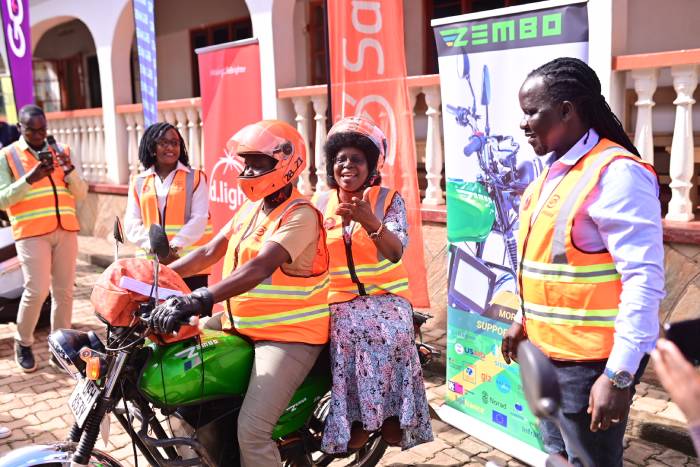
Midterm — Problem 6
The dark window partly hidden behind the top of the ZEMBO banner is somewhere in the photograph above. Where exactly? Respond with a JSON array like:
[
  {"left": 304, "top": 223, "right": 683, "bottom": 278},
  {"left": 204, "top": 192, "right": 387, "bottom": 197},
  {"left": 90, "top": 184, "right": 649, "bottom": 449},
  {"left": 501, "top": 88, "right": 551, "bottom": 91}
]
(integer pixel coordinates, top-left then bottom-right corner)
[{"left": 423, "top": 0, "right": 540, "bottom": 75}]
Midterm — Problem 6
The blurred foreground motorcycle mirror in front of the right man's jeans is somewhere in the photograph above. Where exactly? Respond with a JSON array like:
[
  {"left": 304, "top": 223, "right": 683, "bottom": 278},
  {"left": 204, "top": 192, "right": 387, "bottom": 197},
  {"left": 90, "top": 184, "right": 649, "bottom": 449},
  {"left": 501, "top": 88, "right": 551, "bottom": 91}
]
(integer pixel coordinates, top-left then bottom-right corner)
[{"left": 518, "top": 340, "right": 561, "bottom": 419}]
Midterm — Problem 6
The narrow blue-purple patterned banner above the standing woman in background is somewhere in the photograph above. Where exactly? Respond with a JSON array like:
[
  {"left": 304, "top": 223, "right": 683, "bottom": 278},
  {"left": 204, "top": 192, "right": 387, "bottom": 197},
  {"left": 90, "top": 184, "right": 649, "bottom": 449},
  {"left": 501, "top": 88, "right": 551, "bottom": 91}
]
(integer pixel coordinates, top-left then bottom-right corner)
[{"left": 133, "top": 0, "right": 158, "bottom": 127}]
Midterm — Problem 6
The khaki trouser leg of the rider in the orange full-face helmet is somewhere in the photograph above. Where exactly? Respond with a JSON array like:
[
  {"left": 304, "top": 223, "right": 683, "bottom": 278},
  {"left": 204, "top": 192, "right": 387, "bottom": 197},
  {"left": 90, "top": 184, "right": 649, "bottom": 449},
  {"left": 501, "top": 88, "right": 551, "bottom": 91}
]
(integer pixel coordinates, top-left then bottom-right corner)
[{"left": 238, "top": 341, "right": 323, "bottom": 467}]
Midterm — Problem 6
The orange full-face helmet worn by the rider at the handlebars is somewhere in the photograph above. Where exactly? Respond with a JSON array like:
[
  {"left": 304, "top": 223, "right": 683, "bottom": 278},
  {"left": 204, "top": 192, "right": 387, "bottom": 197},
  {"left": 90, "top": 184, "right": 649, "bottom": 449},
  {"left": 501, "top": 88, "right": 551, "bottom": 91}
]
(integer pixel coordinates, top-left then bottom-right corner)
[{"left": 226, "top": 120, "right": 306, "bottom": 201}]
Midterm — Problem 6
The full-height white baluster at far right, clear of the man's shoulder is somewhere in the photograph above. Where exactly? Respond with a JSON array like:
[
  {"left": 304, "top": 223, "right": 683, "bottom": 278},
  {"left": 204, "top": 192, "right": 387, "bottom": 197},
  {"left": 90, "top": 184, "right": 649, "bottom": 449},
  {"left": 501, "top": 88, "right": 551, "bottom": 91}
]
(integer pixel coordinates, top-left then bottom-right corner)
[{"left": 666, "top": 65, "right": 698, "bottom": 221}]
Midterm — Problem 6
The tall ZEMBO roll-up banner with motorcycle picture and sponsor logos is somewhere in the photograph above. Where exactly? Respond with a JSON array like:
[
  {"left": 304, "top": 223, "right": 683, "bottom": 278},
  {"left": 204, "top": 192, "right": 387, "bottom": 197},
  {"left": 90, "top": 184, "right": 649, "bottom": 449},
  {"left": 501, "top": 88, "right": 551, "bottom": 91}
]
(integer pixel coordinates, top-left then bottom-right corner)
[{"left": 432, "top": 1, "right": 588, "bottom": 465}]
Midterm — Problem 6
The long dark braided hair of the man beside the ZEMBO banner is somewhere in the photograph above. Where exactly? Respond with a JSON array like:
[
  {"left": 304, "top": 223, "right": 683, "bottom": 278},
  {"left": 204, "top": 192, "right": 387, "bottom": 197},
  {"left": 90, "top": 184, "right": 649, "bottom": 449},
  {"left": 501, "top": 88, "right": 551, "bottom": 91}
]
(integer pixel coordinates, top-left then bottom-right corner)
[{"left": 527, "top": 57, "right": 641, "bottom": 157}]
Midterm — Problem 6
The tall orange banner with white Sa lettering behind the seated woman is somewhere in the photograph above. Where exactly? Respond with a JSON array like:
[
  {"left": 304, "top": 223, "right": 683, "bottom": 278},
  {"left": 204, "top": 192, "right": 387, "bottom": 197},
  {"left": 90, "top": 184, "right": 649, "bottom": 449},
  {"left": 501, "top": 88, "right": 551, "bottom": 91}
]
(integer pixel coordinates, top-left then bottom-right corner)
[{"left": 328, "top": 0, "right": 430, "bottom": 307}]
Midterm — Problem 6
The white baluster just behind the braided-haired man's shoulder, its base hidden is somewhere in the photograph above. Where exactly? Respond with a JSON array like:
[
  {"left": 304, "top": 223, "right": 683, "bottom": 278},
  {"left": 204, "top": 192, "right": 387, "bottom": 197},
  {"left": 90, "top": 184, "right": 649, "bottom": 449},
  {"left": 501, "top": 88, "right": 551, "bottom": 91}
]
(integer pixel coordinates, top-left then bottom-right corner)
[{"left": 630, "top": 68, "right": 659, "bottom": 164}]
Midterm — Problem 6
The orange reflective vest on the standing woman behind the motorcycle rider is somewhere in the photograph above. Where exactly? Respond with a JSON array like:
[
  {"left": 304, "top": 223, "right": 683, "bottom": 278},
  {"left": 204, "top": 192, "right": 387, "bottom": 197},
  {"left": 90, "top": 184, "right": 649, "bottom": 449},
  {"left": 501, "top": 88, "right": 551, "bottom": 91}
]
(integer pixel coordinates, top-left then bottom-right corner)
[{"left": 132, "top": 169, "right": 214, "bottom": 274}]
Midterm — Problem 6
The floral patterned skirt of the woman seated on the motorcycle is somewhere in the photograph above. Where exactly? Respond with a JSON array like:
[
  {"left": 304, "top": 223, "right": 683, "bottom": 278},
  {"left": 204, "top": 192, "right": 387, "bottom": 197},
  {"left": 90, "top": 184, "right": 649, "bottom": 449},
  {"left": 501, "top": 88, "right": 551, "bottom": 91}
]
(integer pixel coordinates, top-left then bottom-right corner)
[{"left": 322, "top": 294, "right": 433, "bottom": 453}]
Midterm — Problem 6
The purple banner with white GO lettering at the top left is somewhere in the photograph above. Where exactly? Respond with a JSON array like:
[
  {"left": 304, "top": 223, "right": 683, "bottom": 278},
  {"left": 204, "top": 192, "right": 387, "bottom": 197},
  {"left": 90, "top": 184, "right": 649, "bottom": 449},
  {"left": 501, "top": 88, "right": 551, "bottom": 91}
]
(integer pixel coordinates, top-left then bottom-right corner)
[{"left": 0, "top": 0, "right": 34, "bottom": 111}]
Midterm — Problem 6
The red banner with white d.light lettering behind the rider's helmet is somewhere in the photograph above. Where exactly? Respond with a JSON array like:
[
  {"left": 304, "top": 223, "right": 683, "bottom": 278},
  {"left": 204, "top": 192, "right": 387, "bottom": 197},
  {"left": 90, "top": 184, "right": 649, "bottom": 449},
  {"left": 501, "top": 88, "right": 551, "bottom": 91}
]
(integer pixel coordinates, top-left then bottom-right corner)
[{"left": 196, "top": 39, "right": 262, "bottom": 284}]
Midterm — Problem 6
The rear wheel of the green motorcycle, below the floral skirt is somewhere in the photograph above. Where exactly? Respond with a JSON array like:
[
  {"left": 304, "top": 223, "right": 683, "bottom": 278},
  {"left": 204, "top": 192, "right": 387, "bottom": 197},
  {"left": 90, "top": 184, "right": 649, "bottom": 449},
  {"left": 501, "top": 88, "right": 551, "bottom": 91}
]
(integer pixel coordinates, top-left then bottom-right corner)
[{"left": 284, "top": 393, "right": 389, "bottom": 467}]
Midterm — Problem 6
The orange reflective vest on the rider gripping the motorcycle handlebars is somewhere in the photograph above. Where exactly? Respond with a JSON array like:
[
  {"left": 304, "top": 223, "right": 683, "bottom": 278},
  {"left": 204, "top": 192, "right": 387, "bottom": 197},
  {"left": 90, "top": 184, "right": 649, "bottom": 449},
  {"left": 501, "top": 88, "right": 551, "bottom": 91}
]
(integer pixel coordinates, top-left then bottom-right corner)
[{"left": 222, "top": 189, "right": 330, "bottom": 344}]
